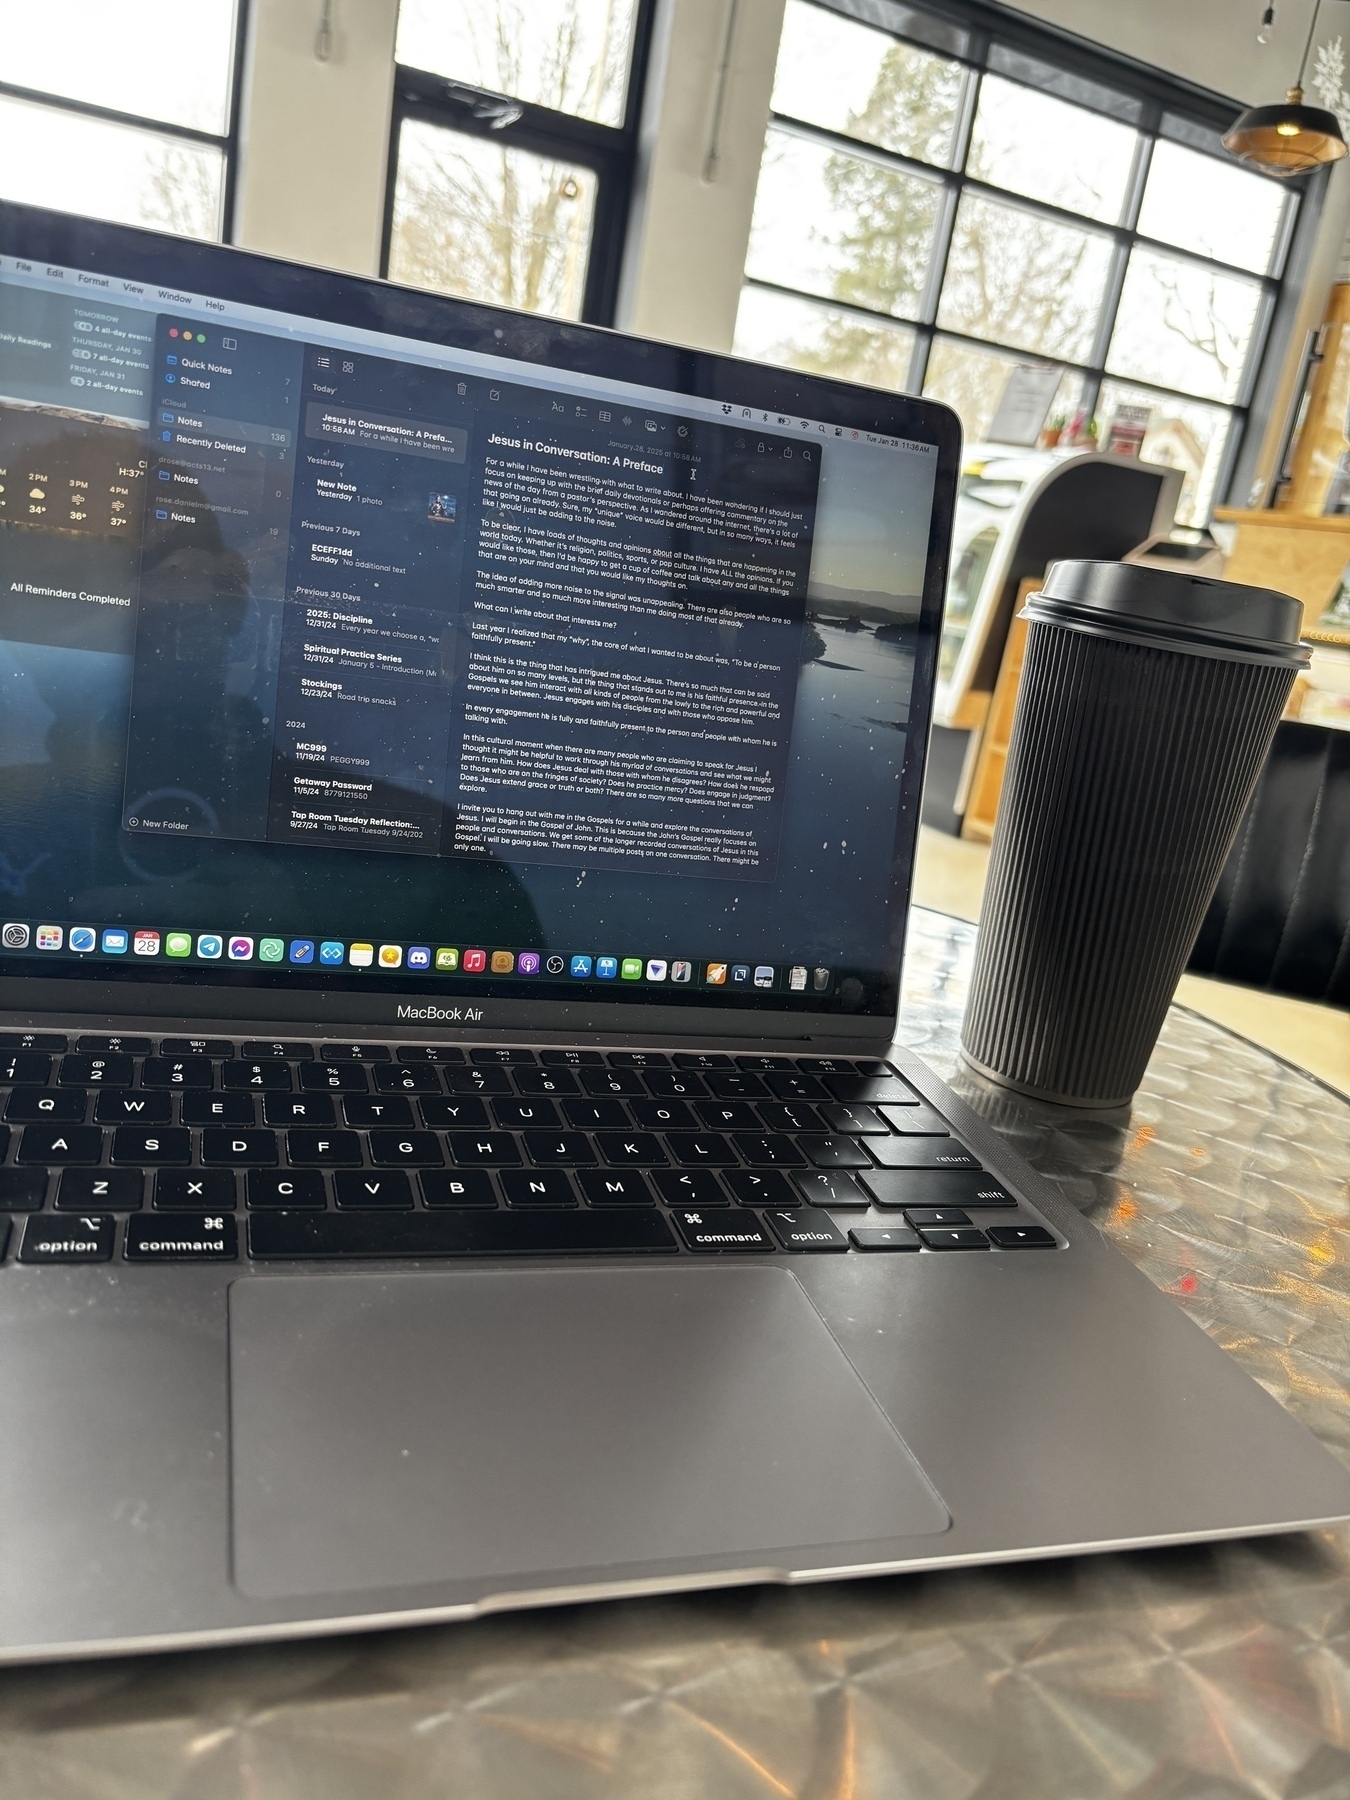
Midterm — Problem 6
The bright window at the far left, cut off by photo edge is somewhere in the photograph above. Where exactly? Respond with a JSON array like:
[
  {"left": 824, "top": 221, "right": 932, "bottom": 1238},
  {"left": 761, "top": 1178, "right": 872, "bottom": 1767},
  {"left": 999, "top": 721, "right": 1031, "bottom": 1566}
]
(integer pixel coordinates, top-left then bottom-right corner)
[{"left": 0, "top": 0, "right": 239, "bottom": 238}]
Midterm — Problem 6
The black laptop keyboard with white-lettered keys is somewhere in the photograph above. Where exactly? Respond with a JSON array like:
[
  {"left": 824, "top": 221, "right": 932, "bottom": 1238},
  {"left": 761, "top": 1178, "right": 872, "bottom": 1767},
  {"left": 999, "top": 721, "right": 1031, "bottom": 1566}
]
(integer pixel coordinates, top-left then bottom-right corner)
[{"left": 0, "top": 1031, "right": 1057, "bottom": 1264}]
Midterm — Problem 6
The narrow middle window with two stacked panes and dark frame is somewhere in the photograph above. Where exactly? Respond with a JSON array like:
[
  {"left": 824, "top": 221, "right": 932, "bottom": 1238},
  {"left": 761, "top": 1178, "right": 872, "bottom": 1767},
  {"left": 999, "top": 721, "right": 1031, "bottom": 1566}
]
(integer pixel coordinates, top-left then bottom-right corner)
[{"left": 383, "top": 0, "right": 652, "bottom": 324}]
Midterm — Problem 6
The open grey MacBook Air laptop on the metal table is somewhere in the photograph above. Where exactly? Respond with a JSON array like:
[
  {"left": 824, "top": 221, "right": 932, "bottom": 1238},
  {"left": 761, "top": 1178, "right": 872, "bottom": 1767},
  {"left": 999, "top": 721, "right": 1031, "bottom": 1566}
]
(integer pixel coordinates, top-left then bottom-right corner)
[{"left": 0, "top": 205, "right": 1350, "bottom": 1660}]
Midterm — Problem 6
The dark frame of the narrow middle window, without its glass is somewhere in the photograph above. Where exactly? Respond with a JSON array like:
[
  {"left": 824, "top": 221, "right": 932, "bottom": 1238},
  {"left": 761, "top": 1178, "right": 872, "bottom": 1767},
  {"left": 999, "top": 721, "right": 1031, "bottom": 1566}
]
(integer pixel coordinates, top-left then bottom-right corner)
[{"left": 380, "top": 0, "right": 657, "bottom": 326}]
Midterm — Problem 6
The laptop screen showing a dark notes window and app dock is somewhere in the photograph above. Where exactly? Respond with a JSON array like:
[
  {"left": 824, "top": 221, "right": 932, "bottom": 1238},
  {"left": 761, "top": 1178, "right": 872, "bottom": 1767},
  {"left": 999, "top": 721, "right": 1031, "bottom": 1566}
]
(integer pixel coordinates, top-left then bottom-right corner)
[{"left": 0, "top": 207, "right": 956, "bottom": 1021}]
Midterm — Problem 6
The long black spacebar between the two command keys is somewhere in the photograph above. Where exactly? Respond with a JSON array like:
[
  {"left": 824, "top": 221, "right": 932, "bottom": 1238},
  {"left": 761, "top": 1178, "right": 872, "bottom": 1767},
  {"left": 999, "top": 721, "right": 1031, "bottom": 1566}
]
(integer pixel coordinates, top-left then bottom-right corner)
[{"left": 248, "top": 1210, "right": 677, "bottom": 1258}]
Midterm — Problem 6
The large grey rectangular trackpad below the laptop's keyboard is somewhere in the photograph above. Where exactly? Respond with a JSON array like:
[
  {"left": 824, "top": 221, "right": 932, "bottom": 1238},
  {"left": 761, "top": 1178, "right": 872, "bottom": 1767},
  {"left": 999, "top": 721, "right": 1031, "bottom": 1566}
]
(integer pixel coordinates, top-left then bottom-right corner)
[{"left": 230, "top": 1265, "right": 950, "bottom": 1598}]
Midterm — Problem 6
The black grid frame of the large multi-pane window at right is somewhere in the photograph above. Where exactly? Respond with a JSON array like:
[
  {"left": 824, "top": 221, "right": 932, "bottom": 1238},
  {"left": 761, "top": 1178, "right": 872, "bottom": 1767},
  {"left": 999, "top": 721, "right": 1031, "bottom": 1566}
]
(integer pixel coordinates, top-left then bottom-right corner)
[{"left": 742, "top": 0, "right": 1325, "bottom": 506}]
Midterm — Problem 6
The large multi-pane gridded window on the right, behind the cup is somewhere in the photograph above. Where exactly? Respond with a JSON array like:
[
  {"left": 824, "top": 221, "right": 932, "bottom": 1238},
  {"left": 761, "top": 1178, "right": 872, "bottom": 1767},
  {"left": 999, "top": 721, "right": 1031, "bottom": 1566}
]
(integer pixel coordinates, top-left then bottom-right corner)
[{"left": 736, "top": 0, "right": 1300, "bottom": 522}]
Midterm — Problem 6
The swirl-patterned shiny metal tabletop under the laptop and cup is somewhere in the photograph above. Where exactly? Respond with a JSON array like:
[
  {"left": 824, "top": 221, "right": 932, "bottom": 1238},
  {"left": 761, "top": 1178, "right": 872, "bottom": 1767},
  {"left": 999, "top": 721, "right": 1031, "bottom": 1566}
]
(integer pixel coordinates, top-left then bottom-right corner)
[{"left": 0, "top": 913, "right": 1350, "bottom": 1800}]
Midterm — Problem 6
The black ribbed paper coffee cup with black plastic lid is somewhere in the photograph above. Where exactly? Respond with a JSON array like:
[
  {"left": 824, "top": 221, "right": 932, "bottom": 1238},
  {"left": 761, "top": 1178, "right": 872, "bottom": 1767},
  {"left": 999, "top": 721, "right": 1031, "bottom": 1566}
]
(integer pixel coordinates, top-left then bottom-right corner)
[{"left": 961, "top": 562, "right": 1310, "bottom": 1107}]
